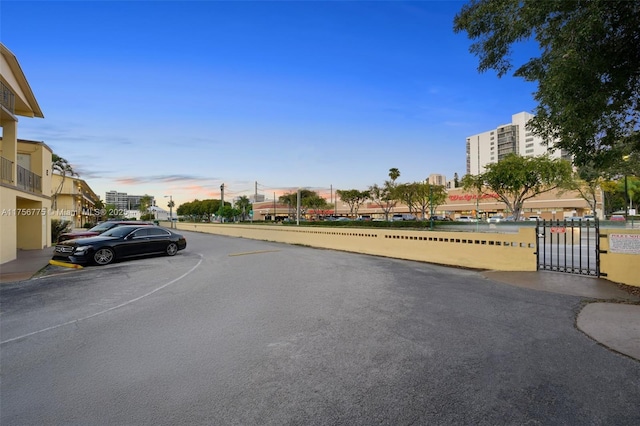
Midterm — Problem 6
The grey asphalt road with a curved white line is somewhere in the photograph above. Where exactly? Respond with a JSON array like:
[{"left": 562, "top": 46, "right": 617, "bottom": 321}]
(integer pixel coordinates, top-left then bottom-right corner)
[{"left": 0, "top": 233, "right": 640, "bottom": 425}]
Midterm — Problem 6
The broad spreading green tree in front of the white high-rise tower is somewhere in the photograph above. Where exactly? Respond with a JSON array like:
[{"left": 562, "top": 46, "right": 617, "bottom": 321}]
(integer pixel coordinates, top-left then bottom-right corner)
[{"left": 462, "top": 154, "right": 571, "bottom": 218}]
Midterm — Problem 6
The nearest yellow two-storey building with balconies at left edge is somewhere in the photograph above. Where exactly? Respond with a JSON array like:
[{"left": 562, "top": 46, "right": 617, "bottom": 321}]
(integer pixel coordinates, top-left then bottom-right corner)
[{"left": 0, "top": 43, "right": 47, "bottom": 264}]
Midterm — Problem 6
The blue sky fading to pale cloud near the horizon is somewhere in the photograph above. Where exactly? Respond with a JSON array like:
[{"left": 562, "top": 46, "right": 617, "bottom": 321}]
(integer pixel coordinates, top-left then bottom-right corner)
[{"left": 0, "top": 0, "right": 535, "bottom": 205}]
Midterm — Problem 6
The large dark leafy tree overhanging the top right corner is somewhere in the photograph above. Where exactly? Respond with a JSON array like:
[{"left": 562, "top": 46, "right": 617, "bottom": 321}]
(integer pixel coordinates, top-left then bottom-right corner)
[{"left": 454, "top": 0, "right": 640, "bottom": 167}]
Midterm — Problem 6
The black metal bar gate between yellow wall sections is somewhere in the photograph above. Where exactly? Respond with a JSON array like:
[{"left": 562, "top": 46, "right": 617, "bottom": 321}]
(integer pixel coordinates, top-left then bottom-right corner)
[{"left": 536, "top": 219, "right": 600, "bottom": 277}]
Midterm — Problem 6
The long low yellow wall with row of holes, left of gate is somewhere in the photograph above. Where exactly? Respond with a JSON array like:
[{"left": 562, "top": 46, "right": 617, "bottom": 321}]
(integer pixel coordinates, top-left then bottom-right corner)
[{"left": 165, "top": 223, "right": 536, "bottom": 271}]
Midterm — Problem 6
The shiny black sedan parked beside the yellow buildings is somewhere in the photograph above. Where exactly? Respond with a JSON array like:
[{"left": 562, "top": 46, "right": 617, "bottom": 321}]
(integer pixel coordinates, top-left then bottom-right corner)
[{"left": 53, "top": 225, "right": 187, "bottom": 265}]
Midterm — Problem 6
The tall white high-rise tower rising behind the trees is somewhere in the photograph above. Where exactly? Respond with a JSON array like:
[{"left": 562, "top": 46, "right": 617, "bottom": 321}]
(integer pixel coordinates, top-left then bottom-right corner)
[{"left": 467, "top": 112, "right": 570, "bottom": 175}]
